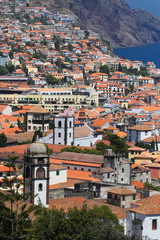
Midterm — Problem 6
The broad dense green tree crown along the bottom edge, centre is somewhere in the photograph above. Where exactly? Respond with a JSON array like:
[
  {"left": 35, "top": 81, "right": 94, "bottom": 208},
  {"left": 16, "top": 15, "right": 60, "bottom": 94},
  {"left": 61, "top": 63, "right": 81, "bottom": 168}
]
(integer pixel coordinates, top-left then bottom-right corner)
[{"left": 34, "top": 204, "right": 127, "bottom": 240}]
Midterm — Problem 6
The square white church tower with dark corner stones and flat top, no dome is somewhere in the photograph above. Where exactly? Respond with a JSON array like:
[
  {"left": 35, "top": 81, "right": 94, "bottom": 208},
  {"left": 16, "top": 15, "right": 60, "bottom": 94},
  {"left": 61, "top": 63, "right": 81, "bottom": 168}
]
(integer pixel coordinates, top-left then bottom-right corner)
[{"left": 53, "top": 116, "right": 74, "bottom": 145}]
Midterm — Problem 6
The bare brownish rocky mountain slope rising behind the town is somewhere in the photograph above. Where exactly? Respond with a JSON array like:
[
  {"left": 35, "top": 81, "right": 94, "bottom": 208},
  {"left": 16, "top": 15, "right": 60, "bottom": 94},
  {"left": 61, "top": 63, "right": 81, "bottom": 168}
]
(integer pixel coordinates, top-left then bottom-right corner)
[{"left": 31, "top": 0, "right": 160, "bottom": 47}]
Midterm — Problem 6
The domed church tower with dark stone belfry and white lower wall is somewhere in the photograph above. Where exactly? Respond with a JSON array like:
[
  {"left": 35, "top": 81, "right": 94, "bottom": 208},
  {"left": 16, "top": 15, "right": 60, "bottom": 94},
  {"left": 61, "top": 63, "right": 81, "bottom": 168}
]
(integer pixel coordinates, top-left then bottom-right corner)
[{"left": 24, "top": 141, "right": 49, "bottom": 207}]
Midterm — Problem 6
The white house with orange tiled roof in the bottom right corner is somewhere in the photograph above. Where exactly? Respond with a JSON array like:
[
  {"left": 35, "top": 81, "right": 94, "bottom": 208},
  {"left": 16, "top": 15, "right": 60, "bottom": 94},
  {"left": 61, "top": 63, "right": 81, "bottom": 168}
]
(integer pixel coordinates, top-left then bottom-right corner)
[{"left": 126, "top": 195, "right": 160, "bottom": 240}]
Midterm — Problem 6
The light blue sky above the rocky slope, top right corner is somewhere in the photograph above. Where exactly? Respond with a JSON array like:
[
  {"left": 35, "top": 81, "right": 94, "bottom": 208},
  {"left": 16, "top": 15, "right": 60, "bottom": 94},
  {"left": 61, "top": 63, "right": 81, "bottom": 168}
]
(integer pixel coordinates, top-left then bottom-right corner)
[{"left": 126, "top": 0, "right": 160, "bottom": 17}]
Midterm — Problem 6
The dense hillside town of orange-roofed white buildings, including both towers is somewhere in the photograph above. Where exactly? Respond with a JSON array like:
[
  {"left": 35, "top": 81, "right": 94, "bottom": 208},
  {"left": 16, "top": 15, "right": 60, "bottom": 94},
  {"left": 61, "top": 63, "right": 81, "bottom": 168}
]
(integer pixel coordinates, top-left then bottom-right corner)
[{"left": 0, "top": 0, "right": 160, "bottom": 239}]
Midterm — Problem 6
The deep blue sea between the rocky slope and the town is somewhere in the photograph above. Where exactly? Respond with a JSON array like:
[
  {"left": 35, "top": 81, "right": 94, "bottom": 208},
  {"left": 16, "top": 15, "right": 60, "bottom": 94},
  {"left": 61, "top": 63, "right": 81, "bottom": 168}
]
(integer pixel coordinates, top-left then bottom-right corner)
[{"left": 114, "top": 43, "right": 160, "bottom": 68}]
